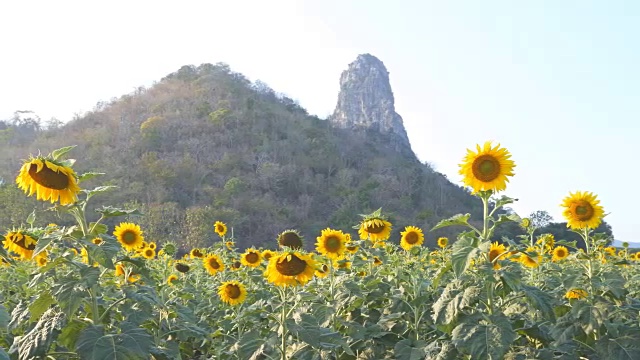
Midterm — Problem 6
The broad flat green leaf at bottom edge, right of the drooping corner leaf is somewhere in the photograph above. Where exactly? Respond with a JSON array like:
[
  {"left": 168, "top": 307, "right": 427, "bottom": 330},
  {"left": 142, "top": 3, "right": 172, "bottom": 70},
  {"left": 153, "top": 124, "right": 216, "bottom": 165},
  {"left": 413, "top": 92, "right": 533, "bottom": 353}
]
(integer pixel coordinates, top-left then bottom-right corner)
[{"left": 76, "top": 322, "right": 153, "bottom": 360}]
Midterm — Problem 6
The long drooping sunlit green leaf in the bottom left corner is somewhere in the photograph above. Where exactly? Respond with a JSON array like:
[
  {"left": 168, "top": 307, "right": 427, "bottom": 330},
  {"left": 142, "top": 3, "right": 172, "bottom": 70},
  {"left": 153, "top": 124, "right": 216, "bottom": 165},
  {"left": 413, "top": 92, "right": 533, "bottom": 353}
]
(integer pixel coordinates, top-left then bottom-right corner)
[{"left": 9, "top": 308, "right": 65, "bottom": 360}]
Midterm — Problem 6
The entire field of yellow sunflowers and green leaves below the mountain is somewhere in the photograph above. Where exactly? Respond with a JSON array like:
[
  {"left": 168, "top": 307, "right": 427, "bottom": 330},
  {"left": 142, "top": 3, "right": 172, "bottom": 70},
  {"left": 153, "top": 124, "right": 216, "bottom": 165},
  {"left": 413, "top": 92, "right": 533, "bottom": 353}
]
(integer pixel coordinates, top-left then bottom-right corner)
[{"left": 0, "top": 142, "right": 640, "bottom": 360}]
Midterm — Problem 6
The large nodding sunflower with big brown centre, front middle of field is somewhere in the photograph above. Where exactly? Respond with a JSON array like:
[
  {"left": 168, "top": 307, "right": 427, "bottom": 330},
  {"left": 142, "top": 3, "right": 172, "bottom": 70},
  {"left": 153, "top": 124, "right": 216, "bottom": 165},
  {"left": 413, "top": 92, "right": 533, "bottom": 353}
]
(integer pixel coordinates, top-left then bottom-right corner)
[{"left": 265, "top": 251, "right": 317, "bottom": 286}]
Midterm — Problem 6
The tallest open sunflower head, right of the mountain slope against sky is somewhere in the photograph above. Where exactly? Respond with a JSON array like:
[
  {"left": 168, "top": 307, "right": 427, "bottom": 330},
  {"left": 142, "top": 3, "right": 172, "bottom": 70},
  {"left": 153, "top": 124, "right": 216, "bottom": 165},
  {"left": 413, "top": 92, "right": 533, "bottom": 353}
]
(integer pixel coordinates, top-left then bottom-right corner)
[{"left": 459, "top": 141, "right": 516, "bottom": 193}]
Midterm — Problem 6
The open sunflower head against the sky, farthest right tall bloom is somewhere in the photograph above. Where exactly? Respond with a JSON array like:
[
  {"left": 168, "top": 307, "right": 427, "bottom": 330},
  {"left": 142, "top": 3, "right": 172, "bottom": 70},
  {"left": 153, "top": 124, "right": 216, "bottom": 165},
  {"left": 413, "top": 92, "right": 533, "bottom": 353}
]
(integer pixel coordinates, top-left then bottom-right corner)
[{"left": 561, "top": 191, "right": 604, "bottom": 230}]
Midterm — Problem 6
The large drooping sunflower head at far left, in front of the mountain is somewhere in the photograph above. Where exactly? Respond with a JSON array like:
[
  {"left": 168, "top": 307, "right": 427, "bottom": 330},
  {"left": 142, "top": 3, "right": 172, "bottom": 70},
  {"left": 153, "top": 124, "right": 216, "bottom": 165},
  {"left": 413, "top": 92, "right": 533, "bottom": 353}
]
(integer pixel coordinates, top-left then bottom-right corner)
[{"left": 16, "top": 156, "right": 80, "bottom": 205}]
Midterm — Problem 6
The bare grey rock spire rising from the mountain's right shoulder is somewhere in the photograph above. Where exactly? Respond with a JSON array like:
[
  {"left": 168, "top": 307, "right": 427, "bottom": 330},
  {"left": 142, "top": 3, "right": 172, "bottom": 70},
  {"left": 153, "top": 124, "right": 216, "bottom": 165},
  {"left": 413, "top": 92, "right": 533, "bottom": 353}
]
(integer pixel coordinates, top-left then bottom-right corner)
[{"left": 329, "top": 54, "right": 413, "bottom": 153}]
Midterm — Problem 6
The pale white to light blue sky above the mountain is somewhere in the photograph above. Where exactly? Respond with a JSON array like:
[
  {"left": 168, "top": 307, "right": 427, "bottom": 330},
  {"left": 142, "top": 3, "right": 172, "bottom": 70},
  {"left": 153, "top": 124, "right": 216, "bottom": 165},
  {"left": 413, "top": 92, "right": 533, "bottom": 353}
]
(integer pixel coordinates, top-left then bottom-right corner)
[{"left": 0, "top": 0, "right": 640, "bottom": 242}]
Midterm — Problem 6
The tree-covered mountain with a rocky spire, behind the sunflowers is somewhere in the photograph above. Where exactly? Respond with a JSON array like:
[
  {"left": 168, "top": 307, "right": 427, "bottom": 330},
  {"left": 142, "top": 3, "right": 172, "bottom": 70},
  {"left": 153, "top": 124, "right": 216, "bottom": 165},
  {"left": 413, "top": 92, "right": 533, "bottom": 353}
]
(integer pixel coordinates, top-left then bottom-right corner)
[{"left": 0, "top": 55, "right": 482, "bottom": 249}]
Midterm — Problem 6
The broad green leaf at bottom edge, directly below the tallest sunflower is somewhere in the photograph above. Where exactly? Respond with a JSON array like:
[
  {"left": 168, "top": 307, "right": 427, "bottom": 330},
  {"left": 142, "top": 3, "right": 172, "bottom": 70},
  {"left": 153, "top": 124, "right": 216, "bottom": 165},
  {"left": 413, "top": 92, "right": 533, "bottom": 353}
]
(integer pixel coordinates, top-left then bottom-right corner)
[{"left": 452, "top": 313, "right": 516, "bottom": 360}]
